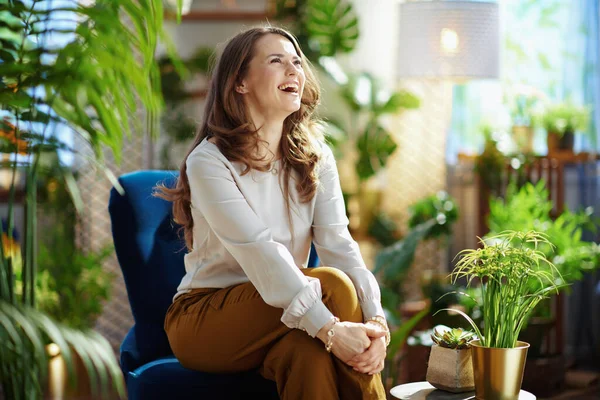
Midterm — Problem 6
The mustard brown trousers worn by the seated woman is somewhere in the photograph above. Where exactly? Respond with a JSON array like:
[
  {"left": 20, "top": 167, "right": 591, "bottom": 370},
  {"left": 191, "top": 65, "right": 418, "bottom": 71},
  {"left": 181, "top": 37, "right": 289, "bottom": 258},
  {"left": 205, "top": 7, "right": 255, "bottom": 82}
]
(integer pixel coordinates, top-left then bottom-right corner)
[{"left": 165, "top": 267, "right": 386, "bottom": 400}]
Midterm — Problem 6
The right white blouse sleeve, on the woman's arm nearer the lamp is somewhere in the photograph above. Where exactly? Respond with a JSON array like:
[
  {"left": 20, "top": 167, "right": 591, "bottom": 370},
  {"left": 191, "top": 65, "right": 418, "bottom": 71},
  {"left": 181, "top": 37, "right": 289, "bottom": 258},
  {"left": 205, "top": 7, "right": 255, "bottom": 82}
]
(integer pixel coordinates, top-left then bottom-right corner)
[{"left": 312, "top": 145, "right": 385, "bottom": 320}]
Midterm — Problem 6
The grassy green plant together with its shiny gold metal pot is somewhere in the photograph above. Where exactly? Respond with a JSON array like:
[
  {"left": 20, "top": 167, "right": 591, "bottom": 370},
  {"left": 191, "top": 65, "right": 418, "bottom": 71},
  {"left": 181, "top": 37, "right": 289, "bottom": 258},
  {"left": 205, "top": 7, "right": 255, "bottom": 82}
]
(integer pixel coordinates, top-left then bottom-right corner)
[{"left": 440, "top": 231, "right": 560, "bottom": 400}]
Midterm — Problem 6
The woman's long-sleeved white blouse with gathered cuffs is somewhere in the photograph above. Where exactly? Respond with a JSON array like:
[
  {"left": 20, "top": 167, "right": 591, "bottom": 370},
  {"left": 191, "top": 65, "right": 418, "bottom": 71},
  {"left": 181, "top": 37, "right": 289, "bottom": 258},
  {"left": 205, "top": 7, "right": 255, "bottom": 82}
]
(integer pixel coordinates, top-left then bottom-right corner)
[{"left": 175, "top": 139, "right": 384, "bottom": 337}]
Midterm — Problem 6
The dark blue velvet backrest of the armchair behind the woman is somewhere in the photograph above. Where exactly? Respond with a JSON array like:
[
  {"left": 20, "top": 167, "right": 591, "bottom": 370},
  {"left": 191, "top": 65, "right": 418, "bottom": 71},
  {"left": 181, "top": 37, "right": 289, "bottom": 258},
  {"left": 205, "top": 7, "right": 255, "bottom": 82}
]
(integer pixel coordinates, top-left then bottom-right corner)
[{"left": 108, "top": 171, "right": 186, "bottom": 360}]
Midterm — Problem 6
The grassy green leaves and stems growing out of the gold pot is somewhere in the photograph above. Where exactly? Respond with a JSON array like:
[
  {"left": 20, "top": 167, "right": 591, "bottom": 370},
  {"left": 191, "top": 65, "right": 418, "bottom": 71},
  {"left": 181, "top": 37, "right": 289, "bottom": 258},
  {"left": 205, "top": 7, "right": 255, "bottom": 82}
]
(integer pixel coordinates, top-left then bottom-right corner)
[{"left": 440, "top": 231, "right": 562, "bottom": 348}]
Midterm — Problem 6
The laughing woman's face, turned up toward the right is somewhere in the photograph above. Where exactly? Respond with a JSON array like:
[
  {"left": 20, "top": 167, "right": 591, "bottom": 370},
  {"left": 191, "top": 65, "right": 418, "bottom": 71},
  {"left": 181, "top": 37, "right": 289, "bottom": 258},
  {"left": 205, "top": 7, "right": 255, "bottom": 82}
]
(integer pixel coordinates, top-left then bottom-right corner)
[{"left": 236, "top": 33, "right": 305, "bottom": 122}]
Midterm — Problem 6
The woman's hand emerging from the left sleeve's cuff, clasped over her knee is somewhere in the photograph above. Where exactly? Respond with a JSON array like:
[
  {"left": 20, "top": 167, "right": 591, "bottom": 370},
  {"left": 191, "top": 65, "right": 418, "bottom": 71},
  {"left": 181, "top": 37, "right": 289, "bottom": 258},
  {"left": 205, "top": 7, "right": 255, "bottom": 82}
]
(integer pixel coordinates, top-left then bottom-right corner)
[{"left": 317, "top": 322, "right": 385, "bottom": 364}]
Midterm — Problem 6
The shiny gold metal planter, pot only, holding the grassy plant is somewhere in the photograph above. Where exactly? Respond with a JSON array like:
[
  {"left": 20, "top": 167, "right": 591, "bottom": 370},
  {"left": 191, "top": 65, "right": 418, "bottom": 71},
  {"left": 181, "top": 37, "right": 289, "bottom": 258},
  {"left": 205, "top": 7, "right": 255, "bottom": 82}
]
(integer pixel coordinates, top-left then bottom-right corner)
[{"left": 471, "top": 340, "right": 529, "bottom": 400}]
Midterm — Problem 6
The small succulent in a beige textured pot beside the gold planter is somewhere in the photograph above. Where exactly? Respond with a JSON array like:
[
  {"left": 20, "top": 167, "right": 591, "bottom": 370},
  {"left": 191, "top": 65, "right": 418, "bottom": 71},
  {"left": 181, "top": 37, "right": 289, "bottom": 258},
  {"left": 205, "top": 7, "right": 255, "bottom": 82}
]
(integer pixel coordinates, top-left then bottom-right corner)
[{"left": 427, "top": 326, "right": 475, "bottom": 393}]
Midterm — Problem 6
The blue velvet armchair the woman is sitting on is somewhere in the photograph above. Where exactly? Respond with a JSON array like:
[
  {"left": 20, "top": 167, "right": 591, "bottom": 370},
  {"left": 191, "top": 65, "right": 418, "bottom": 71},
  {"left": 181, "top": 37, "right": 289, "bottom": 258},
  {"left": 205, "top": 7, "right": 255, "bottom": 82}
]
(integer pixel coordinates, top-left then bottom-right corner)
[{"left": 108, "top": 170, "right": 317, "bottom": 400}]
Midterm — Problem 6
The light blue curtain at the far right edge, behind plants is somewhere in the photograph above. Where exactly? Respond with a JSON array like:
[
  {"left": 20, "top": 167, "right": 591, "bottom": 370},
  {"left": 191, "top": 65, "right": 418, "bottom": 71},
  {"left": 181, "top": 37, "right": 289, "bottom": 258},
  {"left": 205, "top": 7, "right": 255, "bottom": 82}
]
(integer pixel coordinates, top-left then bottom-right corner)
[{"left": 564, "top": 0, "right": 600, "bottom": 367}]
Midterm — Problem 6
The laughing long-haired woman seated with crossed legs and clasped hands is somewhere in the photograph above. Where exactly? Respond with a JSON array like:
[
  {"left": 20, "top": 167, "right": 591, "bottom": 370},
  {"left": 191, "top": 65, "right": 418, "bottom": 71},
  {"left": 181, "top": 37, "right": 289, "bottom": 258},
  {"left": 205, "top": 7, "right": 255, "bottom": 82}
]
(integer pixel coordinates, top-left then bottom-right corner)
[{"left": 159, "top": 27, "right": 389, "bottom": 400}]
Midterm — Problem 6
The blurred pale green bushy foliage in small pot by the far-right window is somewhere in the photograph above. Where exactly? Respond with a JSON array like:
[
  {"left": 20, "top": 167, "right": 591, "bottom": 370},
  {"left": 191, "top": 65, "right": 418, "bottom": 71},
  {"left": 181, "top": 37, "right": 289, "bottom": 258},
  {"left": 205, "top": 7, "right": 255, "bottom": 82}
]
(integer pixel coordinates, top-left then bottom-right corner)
[{"left": 541, "top": 102, "right": 590, "bottom": 136}]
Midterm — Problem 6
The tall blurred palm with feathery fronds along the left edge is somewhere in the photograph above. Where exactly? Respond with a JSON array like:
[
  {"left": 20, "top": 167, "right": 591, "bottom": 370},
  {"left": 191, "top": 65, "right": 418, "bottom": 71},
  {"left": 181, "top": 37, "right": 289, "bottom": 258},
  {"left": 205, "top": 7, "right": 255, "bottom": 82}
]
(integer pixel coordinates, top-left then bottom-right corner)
[{"left": 0, "top": 0, "right": 182, "bottom": 399}]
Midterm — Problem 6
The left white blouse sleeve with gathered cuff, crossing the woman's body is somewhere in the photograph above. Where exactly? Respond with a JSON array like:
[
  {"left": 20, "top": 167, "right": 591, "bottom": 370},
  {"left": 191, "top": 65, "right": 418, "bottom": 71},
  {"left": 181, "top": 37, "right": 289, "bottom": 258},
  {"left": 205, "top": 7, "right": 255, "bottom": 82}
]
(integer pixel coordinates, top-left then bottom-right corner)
[{"left": 186, "top": 151, "right": 333, "bottom": 337}]
